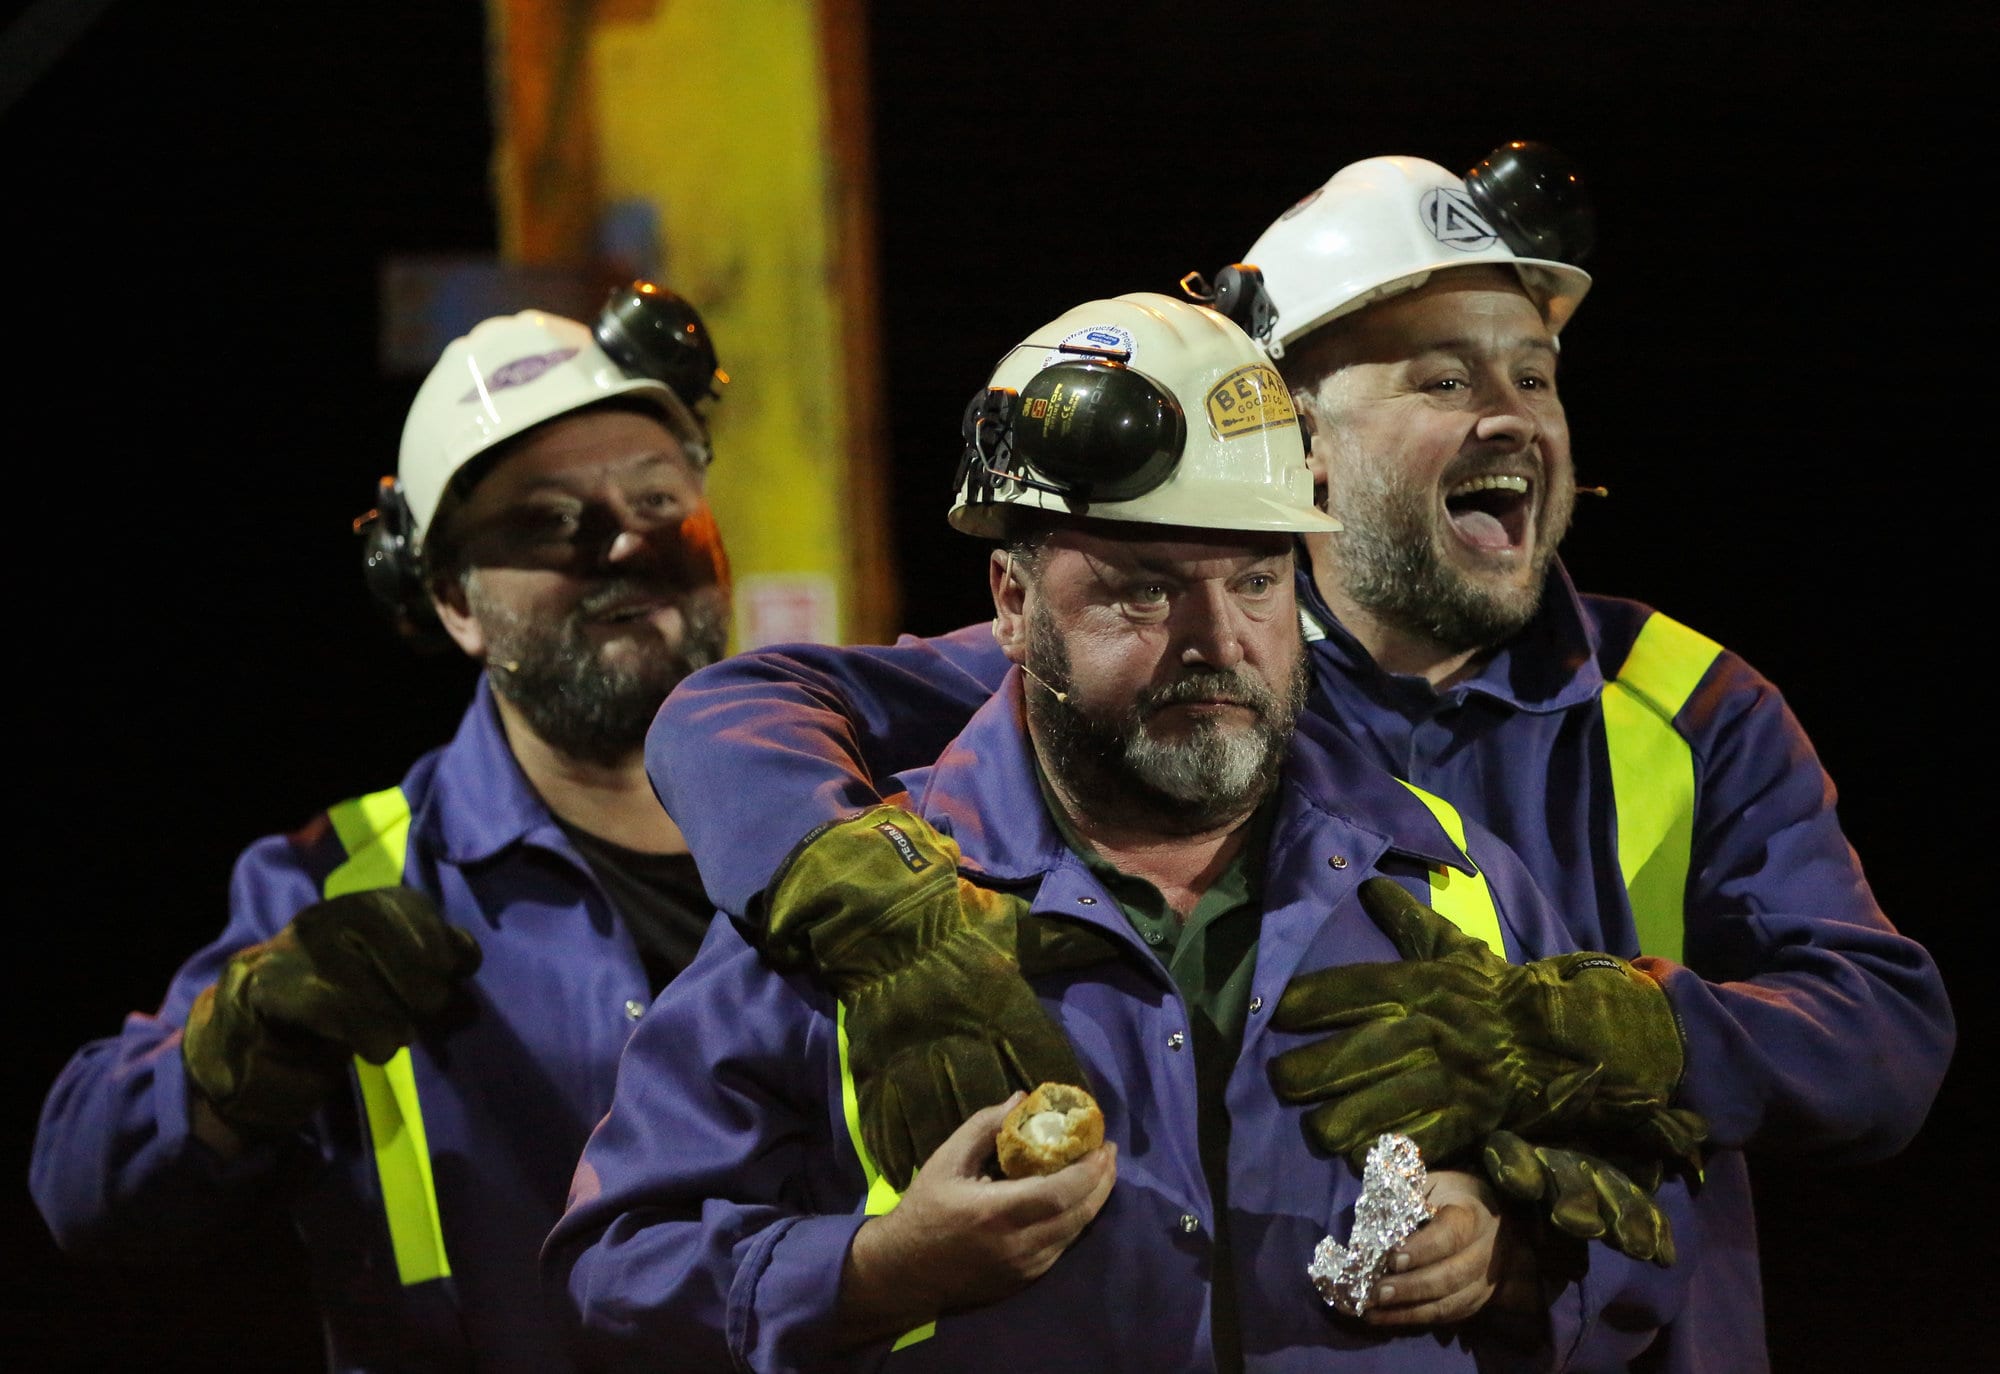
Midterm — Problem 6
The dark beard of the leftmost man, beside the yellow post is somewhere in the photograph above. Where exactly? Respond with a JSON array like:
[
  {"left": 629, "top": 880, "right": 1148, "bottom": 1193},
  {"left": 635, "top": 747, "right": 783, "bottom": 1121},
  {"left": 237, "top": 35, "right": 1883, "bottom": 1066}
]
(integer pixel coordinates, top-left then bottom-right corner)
[{"left": 466, "top": 578, "right": 728, "bottom": 768}]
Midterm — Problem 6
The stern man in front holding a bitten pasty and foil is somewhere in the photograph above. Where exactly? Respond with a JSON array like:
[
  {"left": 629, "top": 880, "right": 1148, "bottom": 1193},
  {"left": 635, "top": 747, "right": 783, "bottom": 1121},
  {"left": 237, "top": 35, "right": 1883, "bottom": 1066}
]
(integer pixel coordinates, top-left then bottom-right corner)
[{"left": 546, "top": 294, "right": 1680, "bottom": 1374}]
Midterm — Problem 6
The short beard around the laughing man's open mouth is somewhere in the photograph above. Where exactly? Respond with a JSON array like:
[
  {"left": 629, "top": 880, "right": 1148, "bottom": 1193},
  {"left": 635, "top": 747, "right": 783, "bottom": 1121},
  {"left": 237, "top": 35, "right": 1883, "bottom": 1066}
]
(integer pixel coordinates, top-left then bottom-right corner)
[{"left": 1334, "top": 460, "right": 1568, "bottom": 652}]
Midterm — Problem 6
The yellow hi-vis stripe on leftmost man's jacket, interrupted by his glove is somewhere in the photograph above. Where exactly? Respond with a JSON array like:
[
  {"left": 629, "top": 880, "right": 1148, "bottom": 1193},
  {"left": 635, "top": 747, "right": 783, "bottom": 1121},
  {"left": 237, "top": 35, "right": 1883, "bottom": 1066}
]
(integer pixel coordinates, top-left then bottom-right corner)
[{"left": 324, "top": 788, "right": 452, "bottom": 1288}]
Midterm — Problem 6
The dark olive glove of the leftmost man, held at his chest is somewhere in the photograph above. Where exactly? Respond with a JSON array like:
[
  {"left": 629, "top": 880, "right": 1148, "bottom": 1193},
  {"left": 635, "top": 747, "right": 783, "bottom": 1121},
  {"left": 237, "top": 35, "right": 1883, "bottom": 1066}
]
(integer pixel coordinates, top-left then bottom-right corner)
[{"left": 180, "top": 888, "right": 480, "bottom": 1136}]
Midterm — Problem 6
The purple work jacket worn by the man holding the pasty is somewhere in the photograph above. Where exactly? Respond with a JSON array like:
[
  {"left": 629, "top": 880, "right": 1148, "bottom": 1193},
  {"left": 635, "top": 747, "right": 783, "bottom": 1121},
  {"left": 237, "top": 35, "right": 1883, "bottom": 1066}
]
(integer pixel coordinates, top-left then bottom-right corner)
[{"left": 546, "top": 678, "right": 1686, "bottom": 1374}]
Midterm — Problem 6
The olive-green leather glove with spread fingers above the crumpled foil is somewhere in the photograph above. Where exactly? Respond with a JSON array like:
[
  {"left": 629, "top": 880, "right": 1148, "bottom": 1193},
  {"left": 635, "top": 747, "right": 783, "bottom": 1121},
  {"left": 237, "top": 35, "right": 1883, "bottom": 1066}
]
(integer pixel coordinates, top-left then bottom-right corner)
[{"left": 1272, "top": 878, "right": 1708, "bottom": 1164}]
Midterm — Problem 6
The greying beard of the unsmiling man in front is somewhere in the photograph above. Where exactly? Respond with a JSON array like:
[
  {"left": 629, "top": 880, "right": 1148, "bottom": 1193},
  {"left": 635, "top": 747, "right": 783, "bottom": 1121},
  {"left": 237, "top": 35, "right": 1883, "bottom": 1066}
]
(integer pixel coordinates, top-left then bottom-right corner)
[{"left": 1026, "top": 604, "right": 1306, "bottom": 834}]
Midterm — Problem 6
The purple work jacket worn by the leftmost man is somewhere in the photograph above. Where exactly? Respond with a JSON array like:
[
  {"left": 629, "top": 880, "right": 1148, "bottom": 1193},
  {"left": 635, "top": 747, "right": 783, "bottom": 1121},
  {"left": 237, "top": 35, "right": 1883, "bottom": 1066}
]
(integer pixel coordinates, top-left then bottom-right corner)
[{"left": 30, "top": 682, "right": 652, "bottom": 1374}]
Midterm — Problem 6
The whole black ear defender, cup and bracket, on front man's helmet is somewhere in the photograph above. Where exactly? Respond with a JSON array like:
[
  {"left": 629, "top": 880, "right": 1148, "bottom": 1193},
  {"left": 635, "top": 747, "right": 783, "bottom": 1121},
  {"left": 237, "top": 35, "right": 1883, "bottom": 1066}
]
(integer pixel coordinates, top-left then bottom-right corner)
[{"left": 954, "top": 356, "right": 1188, "bottom": 508}]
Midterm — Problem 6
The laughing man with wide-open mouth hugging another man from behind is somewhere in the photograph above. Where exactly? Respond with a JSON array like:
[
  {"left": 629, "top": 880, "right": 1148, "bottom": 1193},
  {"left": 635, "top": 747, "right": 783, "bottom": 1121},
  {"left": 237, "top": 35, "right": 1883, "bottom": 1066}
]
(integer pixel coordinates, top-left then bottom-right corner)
[{"left": 1246, "top": 144, "right": 1954, "bottom": 1370}]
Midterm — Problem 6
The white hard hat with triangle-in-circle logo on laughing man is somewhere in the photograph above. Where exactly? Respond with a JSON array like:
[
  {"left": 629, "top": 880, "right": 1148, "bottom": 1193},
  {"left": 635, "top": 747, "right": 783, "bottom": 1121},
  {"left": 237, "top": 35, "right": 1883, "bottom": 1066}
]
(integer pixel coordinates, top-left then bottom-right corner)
[{"left": 1244, "top": 158, "right": 1590, "bottom": 358}]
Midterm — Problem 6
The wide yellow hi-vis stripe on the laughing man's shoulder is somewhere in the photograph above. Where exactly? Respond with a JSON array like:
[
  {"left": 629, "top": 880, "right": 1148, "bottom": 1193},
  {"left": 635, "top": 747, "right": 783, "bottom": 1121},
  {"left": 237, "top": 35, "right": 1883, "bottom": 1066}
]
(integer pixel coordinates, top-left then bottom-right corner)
[{"left": 1604, "top": 612, "right": 1722, "bottom": 964}]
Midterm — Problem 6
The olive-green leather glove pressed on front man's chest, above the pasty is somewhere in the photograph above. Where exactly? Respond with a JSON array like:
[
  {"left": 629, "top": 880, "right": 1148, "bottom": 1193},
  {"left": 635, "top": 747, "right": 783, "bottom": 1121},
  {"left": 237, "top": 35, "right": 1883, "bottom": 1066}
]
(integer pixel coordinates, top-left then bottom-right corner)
[{"left": 766, "top": 806, "right": 1088, "bottom": 1188}]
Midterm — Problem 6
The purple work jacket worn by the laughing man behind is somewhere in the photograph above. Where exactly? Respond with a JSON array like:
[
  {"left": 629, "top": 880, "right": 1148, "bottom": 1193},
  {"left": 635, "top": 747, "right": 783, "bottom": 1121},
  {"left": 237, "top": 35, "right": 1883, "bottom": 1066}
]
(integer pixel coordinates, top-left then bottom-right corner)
[{"left": 646, "top": 564, "right": 1954, "bottom": 1374}]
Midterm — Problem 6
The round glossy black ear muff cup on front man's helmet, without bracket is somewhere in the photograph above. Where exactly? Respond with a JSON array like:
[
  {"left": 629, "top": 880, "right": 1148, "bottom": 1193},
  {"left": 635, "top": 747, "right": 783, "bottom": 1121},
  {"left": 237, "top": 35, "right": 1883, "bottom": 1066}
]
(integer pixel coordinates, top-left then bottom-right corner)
[{"left": 1012, "top": 360, "right": 1188, "bottom": 502}]
